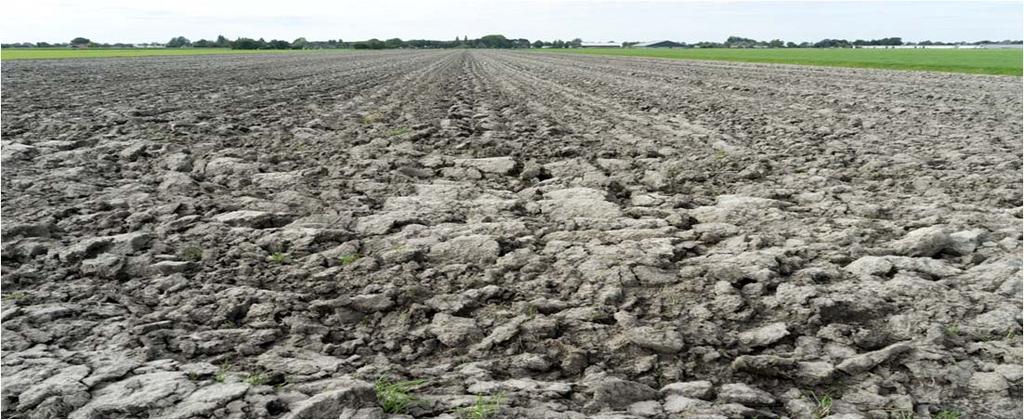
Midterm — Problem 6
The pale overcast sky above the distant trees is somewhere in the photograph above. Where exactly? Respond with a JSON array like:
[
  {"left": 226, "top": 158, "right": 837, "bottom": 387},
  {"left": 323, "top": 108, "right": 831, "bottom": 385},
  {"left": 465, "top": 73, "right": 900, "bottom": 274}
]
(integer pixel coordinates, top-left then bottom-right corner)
[{"left": 0, "top": 0, "right": 1024, "bottom": 43}]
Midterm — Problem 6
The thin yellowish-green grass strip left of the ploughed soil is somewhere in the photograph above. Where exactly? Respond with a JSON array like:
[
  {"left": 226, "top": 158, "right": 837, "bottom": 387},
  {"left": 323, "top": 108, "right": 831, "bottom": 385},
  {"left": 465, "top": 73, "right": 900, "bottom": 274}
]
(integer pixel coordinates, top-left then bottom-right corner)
[{"left": 0, "top": 48, "right": 334, "bottom": 60}]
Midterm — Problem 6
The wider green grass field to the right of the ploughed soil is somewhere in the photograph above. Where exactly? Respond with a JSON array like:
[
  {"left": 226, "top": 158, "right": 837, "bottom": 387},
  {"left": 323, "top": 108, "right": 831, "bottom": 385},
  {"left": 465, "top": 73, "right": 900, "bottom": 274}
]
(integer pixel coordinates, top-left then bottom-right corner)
[{"left": 543, "top": 48, "right": 1024, "bottom": 76}]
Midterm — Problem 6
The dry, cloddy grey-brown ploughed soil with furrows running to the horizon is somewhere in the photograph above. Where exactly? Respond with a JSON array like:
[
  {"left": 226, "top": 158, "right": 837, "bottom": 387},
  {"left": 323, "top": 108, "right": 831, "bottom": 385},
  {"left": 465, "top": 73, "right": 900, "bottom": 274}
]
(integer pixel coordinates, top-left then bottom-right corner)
[{"left": 2, "top": 50, "right": 1022, "bottom": 418}]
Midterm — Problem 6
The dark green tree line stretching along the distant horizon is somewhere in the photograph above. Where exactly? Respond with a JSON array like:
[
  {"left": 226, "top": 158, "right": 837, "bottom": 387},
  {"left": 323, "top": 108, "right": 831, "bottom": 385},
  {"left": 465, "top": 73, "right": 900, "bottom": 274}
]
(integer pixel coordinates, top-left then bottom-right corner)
[{"left": 0, "top": 35, "right": 1022, "bottom": 49}]
